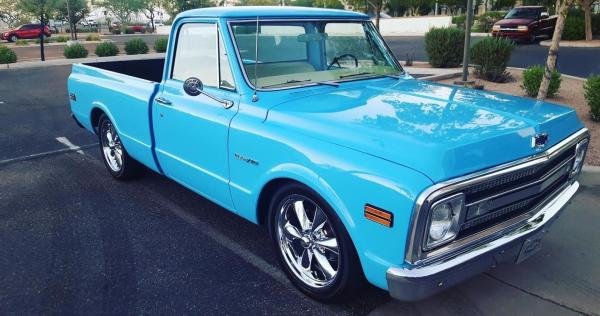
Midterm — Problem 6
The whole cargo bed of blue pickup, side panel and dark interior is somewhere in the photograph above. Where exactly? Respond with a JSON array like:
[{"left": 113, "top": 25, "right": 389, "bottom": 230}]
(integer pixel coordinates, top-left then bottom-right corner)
[{"left": 68, "top": 58, "right": 164, "bottom": 170}]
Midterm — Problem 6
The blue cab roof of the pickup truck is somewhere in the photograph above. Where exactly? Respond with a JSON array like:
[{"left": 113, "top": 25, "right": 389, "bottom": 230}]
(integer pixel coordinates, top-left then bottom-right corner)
[{"left": 177, "top": 6, "right": 369, "bottom": 20}]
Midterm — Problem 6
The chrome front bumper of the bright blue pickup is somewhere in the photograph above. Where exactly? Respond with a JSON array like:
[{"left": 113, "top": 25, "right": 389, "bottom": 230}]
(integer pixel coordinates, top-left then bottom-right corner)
[{"left": 387, "top": 181, "right": 579, "bottom": 301}]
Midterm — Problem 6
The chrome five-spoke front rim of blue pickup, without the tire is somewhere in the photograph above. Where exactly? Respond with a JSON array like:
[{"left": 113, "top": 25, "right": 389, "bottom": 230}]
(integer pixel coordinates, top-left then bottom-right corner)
[{"left": 276, "top": 194, "right": 340, "bottom": 288}]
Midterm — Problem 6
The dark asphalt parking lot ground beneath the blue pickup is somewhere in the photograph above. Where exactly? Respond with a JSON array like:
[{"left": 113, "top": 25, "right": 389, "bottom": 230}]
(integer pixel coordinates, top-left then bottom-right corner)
[{"left": 0, "top": 66, "right": 600, "bottom": 315}]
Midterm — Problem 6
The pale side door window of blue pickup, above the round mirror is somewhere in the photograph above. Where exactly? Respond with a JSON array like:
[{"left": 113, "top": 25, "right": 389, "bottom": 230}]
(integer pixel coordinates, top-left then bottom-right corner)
[{"left": 171, "top": 23, "right": 219, "bottom": 87}]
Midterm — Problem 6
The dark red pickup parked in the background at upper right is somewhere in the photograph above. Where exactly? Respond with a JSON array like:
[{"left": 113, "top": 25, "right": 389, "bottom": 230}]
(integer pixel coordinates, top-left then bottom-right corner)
[{"left": 492, "top": 6, "right": 558, "bottom": 42}]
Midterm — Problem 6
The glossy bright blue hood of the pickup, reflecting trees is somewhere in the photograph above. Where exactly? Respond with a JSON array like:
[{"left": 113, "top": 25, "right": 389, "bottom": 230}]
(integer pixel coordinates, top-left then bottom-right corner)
[{"left": 267, "top": 76, "right": 583, "bottom": 182}]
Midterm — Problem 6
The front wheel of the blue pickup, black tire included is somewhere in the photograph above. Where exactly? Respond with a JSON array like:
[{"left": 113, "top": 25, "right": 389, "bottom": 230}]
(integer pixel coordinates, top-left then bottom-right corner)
[{"left": 268, "top": 183, "right": 364, "bottom": 302}]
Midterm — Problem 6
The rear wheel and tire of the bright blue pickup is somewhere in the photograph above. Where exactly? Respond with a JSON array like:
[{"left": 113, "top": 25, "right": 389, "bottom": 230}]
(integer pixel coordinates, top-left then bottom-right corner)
[{"left": 98, "top": 114, "right": 143, "bottom": 180}]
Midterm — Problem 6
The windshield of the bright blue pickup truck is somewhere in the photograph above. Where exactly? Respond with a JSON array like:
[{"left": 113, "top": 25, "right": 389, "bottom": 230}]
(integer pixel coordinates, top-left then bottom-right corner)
[{"left": 231, "top": 21, "right": 402, "bottom": 89}]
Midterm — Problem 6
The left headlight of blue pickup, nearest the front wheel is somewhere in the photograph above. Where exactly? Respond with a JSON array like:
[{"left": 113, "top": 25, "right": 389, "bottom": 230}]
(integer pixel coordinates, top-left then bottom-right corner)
[{"left": 423, "top": 193, "right": 465, "bottom": 250}]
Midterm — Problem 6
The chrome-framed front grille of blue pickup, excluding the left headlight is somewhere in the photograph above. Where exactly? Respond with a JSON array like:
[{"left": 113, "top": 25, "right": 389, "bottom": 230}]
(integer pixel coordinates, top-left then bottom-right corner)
[{"left": 406, "top": 128, "right": 589, "bottom": 265}]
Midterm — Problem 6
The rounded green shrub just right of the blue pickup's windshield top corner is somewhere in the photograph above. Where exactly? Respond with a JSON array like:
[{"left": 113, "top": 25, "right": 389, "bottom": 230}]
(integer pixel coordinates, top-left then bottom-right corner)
[{"left": 425, "top": 27, "right": 465, "bottom": 68}]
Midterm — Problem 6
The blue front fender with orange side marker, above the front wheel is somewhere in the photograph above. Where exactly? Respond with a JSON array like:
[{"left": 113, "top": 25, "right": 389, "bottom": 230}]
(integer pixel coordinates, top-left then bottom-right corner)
[{"left": 230, "top": 118, "right": 432, "bottom": 289}]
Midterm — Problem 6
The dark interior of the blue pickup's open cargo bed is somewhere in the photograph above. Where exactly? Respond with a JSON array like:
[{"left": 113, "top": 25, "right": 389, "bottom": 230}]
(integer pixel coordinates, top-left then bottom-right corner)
[{"left": 84, "top": 58, "right": 165, "bottom": 82}]
